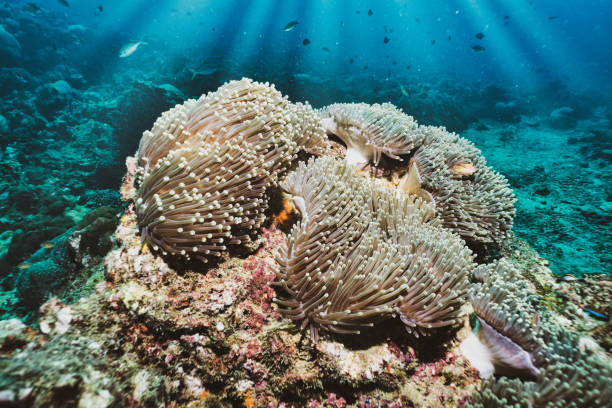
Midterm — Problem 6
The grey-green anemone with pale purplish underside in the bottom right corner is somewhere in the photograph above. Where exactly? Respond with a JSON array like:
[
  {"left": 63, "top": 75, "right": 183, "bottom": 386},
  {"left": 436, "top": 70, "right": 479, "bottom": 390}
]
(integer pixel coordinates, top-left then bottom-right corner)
[{"left": 462, "top": 259, "right": 612, "bottom": 408}]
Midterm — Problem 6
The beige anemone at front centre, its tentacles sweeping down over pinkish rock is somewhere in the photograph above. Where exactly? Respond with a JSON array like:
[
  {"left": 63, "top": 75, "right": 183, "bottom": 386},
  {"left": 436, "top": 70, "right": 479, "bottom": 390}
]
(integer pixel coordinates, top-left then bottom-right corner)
[{"left": 278, "top": 158, "right": 473, "bottom": 339}]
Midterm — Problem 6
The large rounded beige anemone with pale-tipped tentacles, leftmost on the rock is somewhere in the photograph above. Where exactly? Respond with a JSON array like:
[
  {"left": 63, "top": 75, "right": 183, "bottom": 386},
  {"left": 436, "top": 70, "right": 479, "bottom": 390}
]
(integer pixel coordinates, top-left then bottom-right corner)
[{"left": 136, "top": 79, "right": 323, "bottom": 261}]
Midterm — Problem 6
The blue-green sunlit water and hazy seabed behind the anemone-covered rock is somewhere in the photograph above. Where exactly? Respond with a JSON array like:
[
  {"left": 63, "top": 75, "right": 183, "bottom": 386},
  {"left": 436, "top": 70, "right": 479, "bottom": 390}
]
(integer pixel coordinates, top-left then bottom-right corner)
[{"left": 0, "top": 0, "right": 612, "bottom": 313}]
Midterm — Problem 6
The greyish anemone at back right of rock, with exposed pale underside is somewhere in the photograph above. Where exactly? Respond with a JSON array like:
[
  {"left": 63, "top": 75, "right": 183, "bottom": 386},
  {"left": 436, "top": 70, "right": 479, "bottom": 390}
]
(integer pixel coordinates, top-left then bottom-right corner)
[{"left": 320, "top": 103, "right": 516, "bottom": 246}]
